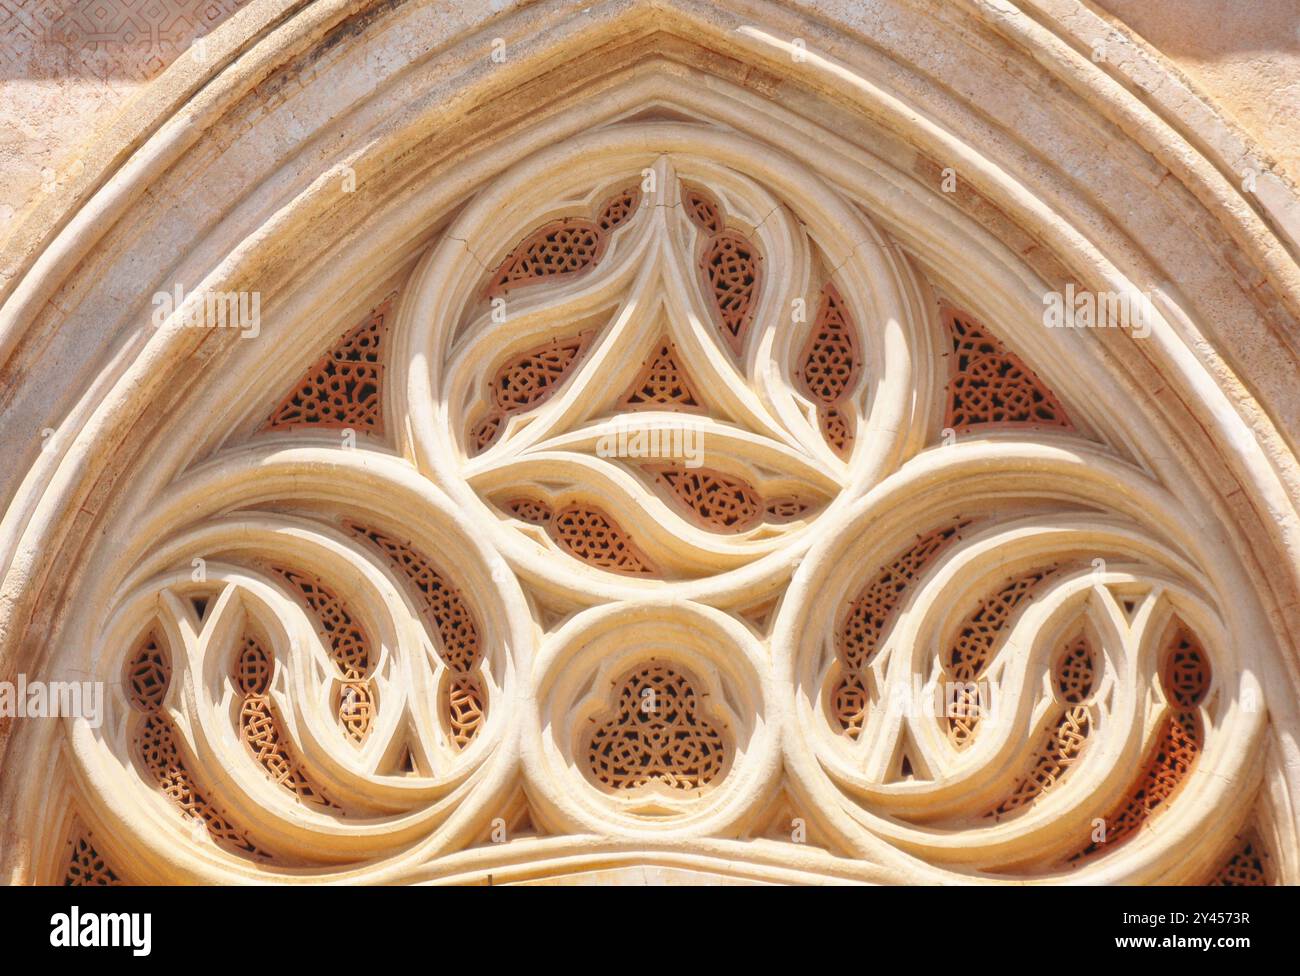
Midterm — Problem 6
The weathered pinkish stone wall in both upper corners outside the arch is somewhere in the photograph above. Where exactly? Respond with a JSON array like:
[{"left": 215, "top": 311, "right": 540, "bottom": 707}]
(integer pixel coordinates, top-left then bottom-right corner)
[{"left": 0, "top": 0, "right": 1300, "bottom": 238}]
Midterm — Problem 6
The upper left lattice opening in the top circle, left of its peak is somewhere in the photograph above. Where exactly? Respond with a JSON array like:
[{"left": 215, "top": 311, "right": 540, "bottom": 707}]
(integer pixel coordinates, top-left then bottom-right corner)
[{"left": 484, "top": 187, "right": 641, "bottom": 298}]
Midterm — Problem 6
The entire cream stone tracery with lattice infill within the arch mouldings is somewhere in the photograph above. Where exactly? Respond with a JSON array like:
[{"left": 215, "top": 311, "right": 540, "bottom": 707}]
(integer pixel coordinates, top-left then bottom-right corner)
[{"left": 45, "top": 122, "right": 1271, "bottom": 884}]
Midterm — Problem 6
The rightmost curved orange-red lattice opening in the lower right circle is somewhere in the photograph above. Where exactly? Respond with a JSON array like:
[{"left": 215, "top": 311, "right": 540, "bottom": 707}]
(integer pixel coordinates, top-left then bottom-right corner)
[{"left": 1070, "top": 626, "right": 1210, "bottom": 862}]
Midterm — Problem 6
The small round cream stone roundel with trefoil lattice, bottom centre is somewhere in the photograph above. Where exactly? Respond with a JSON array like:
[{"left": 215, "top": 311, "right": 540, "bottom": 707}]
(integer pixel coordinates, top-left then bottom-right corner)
[{"left": 529, "top": 600, "right": 775, "bottom": 833}]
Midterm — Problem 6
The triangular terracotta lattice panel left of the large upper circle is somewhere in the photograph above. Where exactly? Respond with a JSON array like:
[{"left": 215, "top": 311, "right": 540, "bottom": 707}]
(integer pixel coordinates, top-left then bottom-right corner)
[{"left": 261, "top": 299, "right": 393, "bottom": 434}]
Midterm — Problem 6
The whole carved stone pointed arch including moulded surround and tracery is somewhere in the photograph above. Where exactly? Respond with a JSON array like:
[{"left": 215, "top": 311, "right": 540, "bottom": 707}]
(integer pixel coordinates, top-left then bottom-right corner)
[{"left": 0, "top": 0, "right": 1300, "bottom": 884}]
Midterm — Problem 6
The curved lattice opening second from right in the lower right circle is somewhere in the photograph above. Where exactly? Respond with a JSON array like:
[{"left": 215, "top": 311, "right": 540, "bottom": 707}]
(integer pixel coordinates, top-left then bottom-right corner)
[{"left": 984, "top": 634, "right": 1096, "bottom": 820}]
